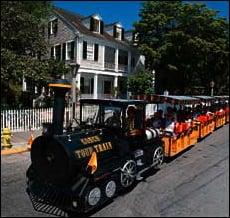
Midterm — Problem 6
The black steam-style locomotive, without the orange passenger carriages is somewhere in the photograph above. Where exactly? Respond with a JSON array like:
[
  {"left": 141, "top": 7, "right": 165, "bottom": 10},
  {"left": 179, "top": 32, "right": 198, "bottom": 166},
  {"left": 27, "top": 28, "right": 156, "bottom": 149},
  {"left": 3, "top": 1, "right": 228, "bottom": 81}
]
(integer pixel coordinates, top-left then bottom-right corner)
[{"left": 26, "top": 80, "right": 164, "bottom": 216}]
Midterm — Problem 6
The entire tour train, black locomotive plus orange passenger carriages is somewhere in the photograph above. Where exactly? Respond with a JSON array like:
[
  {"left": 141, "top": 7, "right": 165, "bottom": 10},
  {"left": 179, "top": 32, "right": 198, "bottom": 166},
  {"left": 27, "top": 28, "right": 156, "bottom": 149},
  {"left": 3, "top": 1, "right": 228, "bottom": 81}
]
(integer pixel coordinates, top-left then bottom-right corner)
[{"left": 26, "top": 80, "right": 229, "bottom": 216}]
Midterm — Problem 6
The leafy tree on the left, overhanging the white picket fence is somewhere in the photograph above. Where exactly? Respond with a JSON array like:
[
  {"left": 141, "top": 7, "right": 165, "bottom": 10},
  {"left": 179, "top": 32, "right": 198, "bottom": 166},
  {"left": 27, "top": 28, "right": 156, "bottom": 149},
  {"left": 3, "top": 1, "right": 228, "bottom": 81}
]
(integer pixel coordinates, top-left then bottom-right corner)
[{"left": 1, "top": 1, "right": 68, "bottom": 106}]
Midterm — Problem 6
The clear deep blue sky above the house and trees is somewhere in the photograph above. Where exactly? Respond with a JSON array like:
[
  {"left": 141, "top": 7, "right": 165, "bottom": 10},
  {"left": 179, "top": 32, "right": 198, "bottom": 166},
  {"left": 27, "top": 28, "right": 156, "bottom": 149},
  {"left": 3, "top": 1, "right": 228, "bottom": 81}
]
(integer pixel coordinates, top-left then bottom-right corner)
[{"left": 53, "top": 0, "right": 229, "bottom": 30}]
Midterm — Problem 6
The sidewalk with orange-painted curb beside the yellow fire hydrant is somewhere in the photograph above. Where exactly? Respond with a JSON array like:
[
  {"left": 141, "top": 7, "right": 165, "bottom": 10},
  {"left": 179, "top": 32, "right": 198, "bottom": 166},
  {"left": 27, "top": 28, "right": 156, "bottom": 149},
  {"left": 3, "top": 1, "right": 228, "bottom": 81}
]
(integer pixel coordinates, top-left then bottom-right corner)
[{"left": 1, "top": 130, "right": 42, "bottom": 155}]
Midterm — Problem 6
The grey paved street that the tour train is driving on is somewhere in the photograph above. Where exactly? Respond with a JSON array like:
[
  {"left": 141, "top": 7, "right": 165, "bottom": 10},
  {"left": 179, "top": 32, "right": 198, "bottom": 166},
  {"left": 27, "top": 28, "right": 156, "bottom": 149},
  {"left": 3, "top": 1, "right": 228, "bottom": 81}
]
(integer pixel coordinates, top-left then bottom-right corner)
[{"left": 1, "top": 125, "right": 229, "bottom": 217}]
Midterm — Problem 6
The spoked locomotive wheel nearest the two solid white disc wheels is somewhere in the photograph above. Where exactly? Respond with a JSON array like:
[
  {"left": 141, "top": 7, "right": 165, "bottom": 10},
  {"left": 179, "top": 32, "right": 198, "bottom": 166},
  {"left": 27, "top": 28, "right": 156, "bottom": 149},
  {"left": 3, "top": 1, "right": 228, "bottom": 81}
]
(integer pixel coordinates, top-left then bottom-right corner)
[{"left": 120, "top": 160, "right": 137, "bottom": 188}]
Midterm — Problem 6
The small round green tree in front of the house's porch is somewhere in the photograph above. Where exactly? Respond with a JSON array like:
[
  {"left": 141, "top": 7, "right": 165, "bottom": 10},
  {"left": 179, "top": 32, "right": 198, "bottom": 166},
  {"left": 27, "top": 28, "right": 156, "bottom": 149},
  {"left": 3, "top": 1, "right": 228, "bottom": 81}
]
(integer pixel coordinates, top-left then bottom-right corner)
[{"left": 127, "top": 69, "right": 154, "bottom": 95}]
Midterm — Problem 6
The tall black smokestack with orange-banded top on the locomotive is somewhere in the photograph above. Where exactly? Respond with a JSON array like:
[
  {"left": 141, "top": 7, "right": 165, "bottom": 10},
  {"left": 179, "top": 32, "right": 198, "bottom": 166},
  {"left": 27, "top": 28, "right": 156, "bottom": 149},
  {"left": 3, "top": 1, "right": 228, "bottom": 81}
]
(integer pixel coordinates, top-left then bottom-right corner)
[{"left": 49, "top": 79, "right": 71, "bottom": 135}]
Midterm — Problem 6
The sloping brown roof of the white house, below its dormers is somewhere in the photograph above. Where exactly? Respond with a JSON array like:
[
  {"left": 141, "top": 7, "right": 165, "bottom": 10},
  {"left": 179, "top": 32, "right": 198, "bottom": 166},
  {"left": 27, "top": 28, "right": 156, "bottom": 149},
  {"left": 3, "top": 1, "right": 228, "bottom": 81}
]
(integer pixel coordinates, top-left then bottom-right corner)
[{"left": 53, "top": 7, "right": 129, "bottom": 46}]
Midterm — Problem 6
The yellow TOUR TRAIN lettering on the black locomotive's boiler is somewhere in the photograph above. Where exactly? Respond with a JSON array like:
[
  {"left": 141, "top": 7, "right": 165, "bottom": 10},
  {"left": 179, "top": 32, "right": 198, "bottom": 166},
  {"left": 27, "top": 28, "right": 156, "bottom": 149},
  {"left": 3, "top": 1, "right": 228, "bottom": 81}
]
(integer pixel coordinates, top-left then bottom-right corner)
[{"left": 75, "top": 142, "right": 113, "bottom": 158}]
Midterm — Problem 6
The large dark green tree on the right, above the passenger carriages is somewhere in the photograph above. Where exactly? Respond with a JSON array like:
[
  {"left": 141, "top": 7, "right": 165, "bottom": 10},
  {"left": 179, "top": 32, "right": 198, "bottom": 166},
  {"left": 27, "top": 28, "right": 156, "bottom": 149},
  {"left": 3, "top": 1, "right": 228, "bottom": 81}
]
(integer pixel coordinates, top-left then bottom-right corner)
[{"left": 134, "top": 1, "right": 229, "bottom": 94}]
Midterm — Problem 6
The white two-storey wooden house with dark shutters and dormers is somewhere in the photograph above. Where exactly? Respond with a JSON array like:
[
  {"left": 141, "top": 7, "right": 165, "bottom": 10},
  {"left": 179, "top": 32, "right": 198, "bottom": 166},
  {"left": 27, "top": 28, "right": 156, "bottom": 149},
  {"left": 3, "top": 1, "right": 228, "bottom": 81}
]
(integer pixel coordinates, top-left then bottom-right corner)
[{"left": 45, "top": 8, "right": 144, "bottom": 98}]
